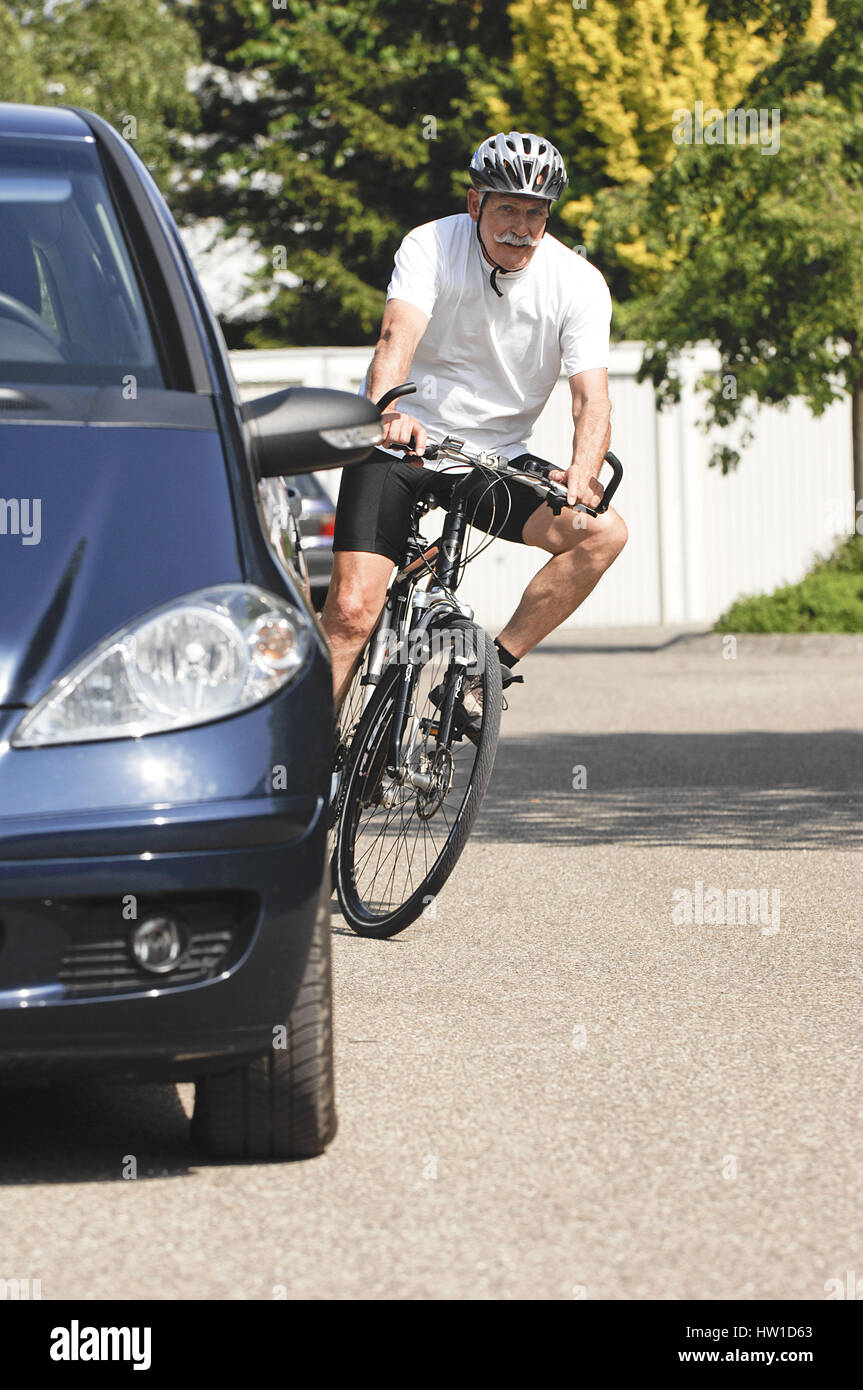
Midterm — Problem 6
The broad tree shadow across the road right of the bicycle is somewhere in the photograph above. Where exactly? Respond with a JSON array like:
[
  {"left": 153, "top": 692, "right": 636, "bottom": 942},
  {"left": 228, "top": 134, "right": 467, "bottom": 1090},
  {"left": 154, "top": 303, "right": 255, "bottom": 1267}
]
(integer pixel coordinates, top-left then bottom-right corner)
[{"left": 472, "top": 730, "right": 863, "bottom": 849}]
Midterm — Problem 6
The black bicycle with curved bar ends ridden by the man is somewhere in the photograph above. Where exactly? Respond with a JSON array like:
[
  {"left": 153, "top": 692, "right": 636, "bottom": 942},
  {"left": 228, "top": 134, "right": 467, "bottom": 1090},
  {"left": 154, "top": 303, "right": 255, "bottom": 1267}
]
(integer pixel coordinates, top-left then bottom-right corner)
[{"left": 331, "top": 382, "right": 623, "bottom": 938}]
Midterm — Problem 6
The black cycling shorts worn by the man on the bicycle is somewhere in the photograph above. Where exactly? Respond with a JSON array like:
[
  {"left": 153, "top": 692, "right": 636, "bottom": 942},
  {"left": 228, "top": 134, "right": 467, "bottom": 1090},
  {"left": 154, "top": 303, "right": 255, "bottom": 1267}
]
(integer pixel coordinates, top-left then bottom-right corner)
[{"left": 332, "top": 449, "right": 543, "bottom": 564}]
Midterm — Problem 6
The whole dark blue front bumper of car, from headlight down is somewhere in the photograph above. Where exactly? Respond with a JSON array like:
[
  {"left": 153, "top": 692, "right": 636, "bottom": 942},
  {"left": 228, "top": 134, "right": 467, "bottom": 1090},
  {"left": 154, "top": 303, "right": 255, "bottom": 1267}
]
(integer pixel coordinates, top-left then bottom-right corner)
[{"left": 0, "top": 644, "right": 331, "bottom": 1084}]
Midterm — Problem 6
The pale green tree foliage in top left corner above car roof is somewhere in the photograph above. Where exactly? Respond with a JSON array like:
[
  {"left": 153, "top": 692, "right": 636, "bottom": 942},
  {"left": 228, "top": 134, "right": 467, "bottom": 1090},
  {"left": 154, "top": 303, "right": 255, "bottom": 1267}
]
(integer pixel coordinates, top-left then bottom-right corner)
[{"left": 0, "top": 0, "right": 200, "bottom": 173}]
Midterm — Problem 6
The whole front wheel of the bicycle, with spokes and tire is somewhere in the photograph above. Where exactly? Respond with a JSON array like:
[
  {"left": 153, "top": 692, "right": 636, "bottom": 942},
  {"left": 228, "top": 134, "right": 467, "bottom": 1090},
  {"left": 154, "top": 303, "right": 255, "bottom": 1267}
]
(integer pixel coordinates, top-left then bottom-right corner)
[{"left": 334, "top": 617, "right": 502, "bottom": 937}]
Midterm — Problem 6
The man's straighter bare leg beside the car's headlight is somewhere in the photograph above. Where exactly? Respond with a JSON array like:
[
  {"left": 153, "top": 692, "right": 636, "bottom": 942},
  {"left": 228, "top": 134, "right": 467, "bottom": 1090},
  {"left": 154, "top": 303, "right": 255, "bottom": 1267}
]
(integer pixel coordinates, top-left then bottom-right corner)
[{"left": 321, "top": 550, "right": 393, "bottom": 714}]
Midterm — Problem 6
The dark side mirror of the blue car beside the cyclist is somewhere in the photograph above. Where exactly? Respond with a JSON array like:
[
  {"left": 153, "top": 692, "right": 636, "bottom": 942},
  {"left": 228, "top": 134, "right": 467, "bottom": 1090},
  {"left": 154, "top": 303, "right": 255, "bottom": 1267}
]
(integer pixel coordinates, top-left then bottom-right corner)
[{"left": 243, "top": 386, "right": 382, "bottom": 478}]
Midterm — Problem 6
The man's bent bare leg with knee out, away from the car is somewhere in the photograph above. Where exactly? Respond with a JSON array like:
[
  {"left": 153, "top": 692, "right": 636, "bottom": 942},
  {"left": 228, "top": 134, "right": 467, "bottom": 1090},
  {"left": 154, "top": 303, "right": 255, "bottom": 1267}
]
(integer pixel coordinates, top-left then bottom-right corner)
[{"left": 498, "top": 506, "right": 627, "bottom": 657}]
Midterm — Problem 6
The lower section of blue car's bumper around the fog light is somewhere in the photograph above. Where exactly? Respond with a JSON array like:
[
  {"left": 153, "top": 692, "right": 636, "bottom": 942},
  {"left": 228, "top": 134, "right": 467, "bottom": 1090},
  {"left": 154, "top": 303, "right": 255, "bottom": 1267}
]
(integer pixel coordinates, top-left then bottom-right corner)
[{"left": 0, "top": 812, "right": 327, "bottom": 1083}]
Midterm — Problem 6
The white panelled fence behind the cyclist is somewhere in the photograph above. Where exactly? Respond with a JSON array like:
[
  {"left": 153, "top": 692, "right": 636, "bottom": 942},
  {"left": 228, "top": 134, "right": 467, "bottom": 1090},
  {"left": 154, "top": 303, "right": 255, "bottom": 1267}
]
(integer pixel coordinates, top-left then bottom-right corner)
[{"left": 231, "top": 343, "right": 853, "bottom": 628}]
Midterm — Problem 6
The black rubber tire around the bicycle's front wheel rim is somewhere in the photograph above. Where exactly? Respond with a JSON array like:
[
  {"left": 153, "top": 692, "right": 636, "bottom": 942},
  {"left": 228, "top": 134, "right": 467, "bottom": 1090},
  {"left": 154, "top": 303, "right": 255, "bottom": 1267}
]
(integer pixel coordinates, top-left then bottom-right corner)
[{"left": 334, "top": 614, "right": 503, "bottom": 940}]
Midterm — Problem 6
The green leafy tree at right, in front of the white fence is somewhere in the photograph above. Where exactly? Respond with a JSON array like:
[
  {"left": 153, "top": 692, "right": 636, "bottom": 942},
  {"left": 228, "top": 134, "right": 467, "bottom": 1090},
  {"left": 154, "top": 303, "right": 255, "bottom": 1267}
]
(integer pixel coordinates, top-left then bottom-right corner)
[{"left": 599, "top": 0, "right": 863, "bottom": 496}]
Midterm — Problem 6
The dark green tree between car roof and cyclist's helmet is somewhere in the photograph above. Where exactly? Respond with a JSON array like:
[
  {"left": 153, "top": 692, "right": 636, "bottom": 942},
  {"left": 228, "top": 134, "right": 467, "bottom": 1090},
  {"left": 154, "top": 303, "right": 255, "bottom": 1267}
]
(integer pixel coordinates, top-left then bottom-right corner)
[{"left": 178, "top": 0, "right": 510, "bottom": 345}]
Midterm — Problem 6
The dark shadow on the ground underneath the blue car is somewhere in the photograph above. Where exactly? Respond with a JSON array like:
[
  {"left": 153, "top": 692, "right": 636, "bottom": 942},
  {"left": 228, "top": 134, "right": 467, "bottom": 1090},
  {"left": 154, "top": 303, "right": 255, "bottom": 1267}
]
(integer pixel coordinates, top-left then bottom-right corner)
[{"left": 0, "top": 1081, "right": 194, "bottom": 1186}]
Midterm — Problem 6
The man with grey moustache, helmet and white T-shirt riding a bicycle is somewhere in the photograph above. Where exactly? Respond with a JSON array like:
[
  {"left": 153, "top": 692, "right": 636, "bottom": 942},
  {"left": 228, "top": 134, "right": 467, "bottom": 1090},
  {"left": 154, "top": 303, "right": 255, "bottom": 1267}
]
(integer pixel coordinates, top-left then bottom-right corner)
[{"left": 321, "top": 131, "right": 627, "bottom": 733}]
